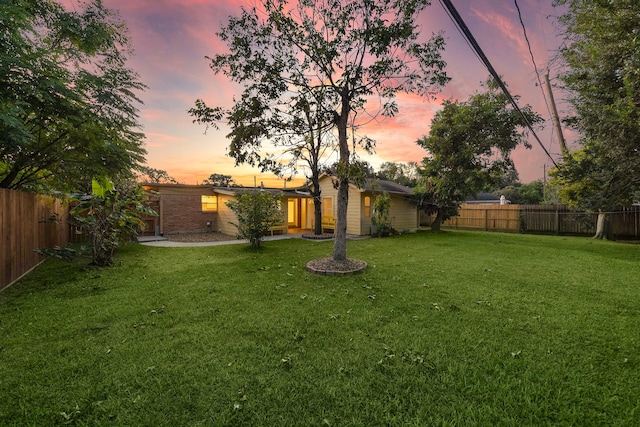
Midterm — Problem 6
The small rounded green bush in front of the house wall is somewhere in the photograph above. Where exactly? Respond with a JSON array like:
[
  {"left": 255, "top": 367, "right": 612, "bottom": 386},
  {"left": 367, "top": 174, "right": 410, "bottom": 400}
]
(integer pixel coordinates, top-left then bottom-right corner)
[{"left": 226, "top": 190, "right": 284, "bottom": 248}]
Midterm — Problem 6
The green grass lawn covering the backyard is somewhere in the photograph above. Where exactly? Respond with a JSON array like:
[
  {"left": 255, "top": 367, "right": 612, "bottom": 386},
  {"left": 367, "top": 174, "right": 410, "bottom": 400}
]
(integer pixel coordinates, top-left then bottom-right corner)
[{"left": 0, "top": 232, "right": 640, "bottom": 426}]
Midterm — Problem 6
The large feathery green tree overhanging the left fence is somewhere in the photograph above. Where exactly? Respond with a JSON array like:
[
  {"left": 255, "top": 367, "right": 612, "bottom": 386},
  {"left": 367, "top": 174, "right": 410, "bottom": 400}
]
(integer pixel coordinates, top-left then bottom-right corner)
[{"left": 0, "top": 0, "right": 145, "bottom": 191}]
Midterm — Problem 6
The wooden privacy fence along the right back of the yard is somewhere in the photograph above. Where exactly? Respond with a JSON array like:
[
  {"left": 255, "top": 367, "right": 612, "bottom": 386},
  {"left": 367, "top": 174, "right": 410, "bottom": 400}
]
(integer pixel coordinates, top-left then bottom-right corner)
[{"left": 442, "top": 204, "right": 640, "bottom": 239}]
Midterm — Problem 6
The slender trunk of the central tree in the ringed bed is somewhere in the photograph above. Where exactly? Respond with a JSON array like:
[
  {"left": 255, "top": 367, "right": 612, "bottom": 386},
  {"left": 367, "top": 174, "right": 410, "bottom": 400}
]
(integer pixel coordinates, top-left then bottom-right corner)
[{"left": 333, "top": 92, "right": 350, "bottom": 261}]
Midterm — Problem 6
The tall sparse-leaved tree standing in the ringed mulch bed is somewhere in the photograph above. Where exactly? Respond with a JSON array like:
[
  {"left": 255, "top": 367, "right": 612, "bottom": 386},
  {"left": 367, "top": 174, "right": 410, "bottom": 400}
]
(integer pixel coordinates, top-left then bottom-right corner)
[{"left": 192, "top": 0, "right": 448, "bottom": 262}]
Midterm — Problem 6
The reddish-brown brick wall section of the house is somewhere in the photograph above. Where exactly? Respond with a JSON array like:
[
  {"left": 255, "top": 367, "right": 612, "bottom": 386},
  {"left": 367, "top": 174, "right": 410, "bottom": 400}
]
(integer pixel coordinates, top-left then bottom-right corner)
[{"left": 160, "top": 194, "right": 218, "bottom": 234}]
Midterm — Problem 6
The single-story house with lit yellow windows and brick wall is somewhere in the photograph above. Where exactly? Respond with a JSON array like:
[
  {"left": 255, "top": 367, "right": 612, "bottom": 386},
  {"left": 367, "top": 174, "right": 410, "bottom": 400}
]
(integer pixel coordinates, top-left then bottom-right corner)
[{"left": 145, "top": 175, "right": 418, "bottom": 236}]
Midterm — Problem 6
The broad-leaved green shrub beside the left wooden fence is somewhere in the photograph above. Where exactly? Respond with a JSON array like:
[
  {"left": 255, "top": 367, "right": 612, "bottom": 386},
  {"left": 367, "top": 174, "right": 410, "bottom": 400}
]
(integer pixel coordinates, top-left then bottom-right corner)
[{"left": 71, "top": 178, "right": 156, "bottom": 267}]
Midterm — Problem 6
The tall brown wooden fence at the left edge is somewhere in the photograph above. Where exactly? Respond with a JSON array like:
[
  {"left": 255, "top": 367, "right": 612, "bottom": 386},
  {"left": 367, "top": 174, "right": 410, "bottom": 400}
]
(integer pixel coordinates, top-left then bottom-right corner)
[{"left": 0, "top": 188, "right": 70, "bottom": 290}]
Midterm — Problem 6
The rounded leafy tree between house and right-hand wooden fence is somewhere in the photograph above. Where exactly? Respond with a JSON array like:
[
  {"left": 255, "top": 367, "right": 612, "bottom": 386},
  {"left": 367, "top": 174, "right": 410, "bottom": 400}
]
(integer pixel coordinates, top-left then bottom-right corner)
[{"left": 416, "top": 79, "right": 542, "bottom": 230}]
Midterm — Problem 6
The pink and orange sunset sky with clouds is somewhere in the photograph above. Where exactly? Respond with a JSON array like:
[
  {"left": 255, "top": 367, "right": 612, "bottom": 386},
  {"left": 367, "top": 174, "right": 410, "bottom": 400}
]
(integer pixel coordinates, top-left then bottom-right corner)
[{"left": 63, "top": 0, "right": 571, "bottom": 186}]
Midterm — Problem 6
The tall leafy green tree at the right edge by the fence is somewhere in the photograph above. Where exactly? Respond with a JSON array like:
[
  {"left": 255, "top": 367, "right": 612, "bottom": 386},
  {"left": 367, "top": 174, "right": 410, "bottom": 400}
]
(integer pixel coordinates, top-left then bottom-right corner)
[{"left": 553, "top": 0, "right": 640, "bottom": 238}]
